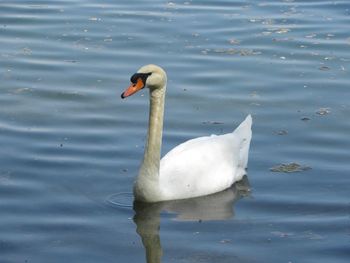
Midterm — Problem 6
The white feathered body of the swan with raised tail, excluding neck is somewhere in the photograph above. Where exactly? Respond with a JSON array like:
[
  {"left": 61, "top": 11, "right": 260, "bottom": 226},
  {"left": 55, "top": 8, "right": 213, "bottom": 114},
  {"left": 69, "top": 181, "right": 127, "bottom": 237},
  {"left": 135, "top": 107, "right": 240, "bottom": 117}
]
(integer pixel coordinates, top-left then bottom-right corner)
[{"left": 159, "top": 115, "right": 252, "bottom": 200}]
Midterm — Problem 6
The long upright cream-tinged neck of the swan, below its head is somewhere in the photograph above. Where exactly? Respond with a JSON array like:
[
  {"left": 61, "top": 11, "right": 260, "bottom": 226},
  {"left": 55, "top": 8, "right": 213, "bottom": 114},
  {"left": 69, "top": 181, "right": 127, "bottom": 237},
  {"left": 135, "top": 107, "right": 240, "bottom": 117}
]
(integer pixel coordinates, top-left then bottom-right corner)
[{"left": 139, "top": 86, "right": 166, "bottom": 183}]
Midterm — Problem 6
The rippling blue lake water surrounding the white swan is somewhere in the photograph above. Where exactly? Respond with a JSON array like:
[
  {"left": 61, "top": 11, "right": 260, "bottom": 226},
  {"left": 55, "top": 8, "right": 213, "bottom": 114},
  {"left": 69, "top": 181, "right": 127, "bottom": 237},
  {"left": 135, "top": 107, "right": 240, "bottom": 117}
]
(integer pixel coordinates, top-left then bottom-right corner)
[{"left": 0, "top": 0, "right": 350, "bottom": 263}]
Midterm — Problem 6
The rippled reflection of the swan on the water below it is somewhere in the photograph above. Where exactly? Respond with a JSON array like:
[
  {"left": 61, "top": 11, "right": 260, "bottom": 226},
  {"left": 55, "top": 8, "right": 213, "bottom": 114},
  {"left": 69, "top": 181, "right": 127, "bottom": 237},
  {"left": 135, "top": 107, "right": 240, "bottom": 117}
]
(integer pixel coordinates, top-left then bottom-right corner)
[{"left": 134, "top": 176, "right": 250, "bottom": 263}]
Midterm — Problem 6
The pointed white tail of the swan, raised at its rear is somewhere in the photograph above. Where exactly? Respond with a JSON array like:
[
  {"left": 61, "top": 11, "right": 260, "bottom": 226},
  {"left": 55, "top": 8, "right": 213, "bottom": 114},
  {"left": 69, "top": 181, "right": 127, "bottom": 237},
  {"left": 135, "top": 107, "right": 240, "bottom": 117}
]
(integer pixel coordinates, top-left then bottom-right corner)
[{"left": 233, "top": 114, "right": 253, "bottom": 170}]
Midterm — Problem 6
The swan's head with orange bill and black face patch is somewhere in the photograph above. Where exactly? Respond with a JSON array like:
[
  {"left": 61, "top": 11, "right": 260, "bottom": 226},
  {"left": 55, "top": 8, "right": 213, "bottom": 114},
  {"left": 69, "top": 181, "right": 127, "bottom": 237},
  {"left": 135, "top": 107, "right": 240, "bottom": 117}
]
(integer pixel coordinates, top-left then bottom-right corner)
[{"left": 121, "top": 64, "right": 167, "bottom": 99}]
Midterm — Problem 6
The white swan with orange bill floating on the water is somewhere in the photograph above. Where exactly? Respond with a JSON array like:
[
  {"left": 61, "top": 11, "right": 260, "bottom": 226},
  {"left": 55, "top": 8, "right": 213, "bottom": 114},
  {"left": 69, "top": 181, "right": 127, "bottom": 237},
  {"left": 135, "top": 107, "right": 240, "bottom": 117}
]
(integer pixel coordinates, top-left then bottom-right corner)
[{"left": 121, "top": 64, "right": 252, "bottom": 202}]
